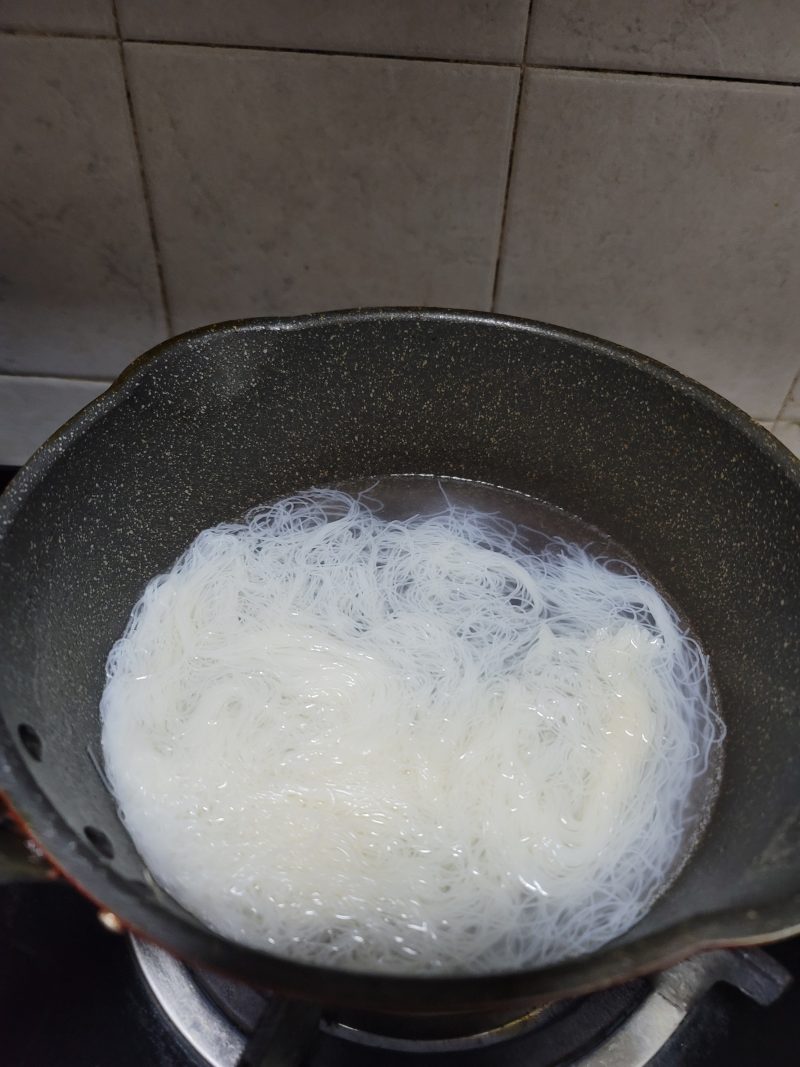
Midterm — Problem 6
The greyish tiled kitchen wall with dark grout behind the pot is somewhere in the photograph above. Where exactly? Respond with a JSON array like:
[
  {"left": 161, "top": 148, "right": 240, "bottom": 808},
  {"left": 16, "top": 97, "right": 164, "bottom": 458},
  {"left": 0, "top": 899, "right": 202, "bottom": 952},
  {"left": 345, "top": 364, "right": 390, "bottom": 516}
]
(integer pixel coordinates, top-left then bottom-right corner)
[{"left": 0, "top": 0, "right": 800, "bottom": 463}]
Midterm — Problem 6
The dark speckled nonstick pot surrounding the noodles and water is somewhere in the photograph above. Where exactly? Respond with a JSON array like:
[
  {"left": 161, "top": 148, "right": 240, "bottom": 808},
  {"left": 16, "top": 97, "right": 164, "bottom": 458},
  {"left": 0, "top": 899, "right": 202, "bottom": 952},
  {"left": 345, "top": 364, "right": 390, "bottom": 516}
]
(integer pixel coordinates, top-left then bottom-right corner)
[{"left": 0, "top": 309, "right": 800, "bottom": 1012}]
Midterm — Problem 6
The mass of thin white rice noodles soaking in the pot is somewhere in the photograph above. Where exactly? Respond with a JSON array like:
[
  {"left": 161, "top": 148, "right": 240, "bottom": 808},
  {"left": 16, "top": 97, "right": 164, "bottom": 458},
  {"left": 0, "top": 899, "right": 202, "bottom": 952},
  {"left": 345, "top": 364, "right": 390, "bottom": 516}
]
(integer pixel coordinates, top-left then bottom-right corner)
[{"left": 101, "top": 490, "right": 723, "bottom": 973}]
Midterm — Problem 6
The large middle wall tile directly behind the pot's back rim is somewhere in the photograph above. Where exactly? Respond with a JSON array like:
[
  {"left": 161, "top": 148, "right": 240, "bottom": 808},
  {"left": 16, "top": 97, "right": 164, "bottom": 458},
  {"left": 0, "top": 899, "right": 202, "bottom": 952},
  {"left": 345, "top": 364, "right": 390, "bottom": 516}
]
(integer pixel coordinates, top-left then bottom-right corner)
[{"left": 126, "top": 44, "right": 518, "bottom": 329}]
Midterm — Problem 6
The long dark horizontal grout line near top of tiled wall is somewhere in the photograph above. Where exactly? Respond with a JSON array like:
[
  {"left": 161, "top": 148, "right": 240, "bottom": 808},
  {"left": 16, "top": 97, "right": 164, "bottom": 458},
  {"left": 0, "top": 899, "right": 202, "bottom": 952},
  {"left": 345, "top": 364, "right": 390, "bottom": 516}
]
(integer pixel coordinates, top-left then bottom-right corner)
[{"left": 0, "top": 28, "right": 800, "bottom": 89}]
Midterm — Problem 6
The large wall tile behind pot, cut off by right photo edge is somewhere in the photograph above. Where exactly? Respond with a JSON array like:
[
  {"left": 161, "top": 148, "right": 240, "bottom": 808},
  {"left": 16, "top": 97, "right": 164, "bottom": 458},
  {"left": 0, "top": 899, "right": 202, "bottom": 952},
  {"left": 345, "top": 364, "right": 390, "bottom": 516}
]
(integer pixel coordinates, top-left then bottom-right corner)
[{"left": 498, "top": 71, "right": 800, "bottom": 419}]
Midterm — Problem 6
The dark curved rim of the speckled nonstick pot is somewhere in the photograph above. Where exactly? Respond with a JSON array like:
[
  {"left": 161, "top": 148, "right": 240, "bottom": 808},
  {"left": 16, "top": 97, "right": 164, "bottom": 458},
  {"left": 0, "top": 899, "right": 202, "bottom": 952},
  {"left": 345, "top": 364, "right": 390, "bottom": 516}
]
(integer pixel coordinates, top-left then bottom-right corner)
[{"left": 0, "top": 307, "right": 800, "bottom": 1012}]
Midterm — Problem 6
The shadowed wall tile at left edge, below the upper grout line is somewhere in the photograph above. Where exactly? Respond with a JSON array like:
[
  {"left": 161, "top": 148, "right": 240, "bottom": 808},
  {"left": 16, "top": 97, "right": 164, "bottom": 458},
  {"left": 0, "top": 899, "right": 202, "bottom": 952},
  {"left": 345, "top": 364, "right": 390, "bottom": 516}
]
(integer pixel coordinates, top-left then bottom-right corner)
[{"left": 0, "top": 36, "right": 165, "bottom": 378}]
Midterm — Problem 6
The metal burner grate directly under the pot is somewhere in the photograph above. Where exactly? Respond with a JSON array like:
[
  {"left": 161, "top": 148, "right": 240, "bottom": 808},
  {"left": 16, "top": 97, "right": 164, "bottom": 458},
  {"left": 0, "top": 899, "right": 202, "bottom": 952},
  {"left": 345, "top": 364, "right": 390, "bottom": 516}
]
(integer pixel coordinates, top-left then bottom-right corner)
[{"left": 132, "top": 939, "right": 791, "bottom": 1067}]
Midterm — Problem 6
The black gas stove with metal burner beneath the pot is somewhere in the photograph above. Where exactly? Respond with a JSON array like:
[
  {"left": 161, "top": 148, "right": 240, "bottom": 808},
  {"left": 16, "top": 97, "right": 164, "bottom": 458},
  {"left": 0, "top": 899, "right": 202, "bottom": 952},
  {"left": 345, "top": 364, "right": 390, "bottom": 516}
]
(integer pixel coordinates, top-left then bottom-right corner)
[{"left": 0, "top": 468, "right": 800, "bottom": 1067}]
